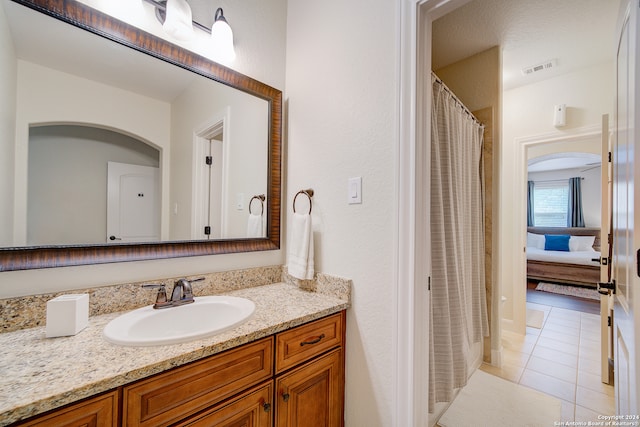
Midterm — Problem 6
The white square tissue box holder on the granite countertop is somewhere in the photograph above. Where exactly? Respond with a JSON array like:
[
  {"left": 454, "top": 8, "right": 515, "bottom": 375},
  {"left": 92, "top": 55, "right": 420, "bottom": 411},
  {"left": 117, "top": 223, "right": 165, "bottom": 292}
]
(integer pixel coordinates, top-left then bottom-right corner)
[{"left": 46, "top": 294, "right": 89, "bottom": 338}]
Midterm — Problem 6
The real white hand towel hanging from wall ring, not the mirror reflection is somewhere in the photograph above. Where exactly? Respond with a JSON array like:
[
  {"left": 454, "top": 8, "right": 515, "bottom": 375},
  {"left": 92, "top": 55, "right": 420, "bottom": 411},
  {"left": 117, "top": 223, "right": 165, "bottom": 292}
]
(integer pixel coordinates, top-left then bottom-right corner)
[{"left": 288, "top": 213, "right": 314, "bottom": 280}]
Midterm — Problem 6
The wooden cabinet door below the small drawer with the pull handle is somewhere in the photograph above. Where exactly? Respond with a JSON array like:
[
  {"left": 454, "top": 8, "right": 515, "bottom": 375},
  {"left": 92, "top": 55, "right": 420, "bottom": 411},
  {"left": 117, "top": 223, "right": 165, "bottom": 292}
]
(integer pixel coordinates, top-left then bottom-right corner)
[{"left": 276, "top": 349, "right": 344, "bottom": 427}]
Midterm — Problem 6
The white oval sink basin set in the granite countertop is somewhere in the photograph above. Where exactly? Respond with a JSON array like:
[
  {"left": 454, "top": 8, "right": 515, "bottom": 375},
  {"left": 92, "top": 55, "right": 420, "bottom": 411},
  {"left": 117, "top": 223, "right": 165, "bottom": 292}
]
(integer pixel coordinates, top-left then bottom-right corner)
[{"left": 103, "top": 295, "right": 256, "bottom": 347}]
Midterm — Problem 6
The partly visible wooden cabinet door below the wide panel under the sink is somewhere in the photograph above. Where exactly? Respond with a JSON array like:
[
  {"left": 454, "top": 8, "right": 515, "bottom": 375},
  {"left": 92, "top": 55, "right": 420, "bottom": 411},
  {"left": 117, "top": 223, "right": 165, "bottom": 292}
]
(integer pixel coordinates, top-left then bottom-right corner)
[{"left": 176, "top": 381, "right": 273, "bottom": 427}]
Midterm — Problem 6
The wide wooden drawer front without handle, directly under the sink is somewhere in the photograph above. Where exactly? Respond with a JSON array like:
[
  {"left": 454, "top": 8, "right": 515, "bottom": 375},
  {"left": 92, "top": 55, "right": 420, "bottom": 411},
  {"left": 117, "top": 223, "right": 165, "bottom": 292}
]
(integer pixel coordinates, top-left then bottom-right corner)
[{"left": 123, "top": 337, "right": 273, "bottom": 427}]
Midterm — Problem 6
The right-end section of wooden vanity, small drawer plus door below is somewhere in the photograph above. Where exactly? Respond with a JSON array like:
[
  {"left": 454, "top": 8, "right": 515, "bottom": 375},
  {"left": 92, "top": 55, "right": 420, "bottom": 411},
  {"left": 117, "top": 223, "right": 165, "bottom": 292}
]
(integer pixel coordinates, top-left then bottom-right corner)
[{"left": 275, "top": 312, "right": 344, "bottom": 427}]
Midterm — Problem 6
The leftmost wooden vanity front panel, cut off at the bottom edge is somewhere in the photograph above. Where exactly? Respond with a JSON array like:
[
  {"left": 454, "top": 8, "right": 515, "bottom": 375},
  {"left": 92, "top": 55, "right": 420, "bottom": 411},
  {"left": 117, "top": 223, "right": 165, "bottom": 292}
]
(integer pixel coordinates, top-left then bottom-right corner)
[{"left": 18, "top": 391, "right": 118, "bottom": 427}]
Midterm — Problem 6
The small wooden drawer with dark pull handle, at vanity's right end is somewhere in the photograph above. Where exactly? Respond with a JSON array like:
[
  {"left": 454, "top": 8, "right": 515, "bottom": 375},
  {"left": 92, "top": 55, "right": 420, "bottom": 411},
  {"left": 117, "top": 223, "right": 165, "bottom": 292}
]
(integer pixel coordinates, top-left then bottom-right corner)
[{"left": 276, "top": 312, "right": 344, "bottom": 374}]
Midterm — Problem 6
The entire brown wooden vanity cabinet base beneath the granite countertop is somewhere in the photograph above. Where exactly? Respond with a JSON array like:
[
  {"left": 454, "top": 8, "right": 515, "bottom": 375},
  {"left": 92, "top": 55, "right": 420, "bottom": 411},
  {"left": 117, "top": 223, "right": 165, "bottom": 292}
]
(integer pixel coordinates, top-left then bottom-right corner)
[{"left": 15, "top": 312, "right": 345, "bottom": 427}]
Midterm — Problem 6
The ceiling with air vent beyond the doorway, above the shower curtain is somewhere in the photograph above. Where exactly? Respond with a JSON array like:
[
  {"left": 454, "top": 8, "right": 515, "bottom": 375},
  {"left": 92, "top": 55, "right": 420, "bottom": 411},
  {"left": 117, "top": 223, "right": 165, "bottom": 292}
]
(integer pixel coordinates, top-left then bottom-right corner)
[{"left": 432, "top": 0, "right": 620, "bottom": 90}]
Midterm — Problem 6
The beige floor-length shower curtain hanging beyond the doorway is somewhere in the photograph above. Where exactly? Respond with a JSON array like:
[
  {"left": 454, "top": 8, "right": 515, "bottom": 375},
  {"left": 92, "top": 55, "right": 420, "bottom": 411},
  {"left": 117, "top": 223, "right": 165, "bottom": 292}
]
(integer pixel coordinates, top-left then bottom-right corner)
[{"left": 429, "top": 74, "right": 489, "bottom": 412}]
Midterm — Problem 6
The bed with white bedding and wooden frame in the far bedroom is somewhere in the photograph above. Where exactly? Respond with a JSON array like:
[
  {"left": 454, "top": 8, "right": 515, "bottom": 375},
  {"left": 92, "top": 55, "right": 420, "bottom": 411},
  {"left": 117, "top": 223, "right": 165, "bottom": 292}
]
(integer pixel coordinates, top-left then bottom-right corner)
[{"left": 527, "top": 227, "right": 600, "bottom": 288}]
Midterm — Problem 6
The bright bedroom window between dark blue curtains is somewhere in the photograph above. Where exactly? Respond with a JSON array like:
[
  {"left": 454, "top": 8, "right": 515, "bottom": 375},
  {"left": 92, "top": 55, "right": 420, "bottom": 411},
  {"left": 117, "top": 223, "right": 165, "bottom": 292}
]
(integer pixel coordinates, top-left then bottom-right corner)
[{"left": 533, "top": 181, "right": 569, "bottom": 227}]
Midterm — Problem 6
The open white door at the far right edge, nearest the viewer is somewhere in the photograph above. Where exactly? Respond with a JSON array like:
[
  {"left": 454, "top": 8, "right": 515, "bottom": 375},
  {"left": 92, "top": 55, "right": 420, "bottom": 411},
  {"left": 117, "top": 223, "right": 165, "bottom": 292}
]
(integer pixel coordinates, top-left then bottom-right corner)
[{"left": 612, "top": 0, "right": 640, "bottom": 415}]
